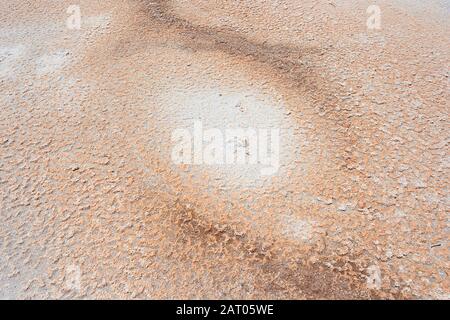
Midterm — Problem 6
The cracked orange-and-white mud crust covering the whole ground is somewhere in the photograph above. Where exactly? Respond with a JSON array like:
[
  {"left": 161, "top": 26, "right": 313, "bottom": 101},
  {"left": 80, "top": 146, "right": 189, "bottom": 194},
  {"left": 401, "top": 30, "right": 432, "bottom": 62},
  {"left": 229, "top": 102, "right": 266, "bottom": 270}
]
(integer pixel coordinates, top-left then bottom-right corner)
[{"left": 0, "top": 0, "right": 450, "bottom": 299}]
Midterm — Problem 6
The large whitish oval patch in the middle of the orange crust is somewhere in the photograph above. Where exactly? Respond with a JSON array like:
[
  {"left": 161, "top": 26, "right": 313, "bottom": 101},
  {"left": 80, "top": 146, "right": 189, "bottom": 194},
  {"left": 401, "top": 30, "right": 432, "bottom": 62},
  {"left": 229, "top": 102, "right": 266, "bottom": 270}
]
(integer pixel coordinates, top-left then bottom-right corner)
[{"left": 151, "top": 68, "right": 303, "bottom": 188}]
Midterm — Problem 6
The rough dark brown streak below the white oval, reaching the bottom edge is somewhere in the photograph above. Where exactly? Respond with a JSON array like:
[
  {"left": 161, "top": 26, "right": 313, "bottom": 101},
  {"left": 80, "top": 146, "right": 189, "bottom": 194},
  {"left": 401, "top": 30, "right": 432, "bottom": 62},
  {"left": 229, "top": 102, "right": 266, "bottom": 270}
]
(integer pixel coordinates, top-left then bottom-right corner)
[{"left": 169, "top": 200, "right": 378, "bottom": 299}]
